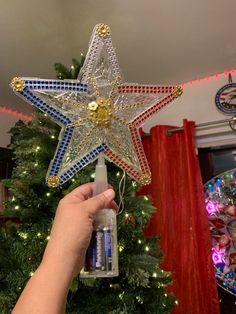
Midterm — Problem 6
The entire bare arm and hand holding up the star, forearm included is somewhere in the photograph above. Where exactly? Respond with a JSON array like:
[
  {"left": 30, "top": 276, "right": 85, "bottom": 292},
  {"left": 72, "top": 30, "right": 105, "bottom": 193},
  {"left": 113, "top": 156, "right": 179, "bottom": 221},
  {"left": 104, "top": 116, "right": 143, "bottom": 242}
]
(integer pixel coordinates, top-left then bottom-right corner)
[{"left": 12, "top": 183, "right": 117, "bottom": 314}]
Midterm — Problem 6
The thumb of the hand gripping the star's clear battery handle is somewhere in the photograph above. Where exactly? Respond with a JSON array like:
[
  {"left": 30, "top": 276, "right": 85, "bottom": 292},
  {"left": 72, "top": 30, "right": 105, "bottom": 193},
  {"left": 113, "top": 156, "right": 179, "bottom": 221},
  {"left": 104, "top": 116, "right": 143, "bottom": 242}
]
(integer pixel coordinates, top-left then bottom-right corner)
[{"left": 84, "top": 189, "right": 115, "bottom": 215}]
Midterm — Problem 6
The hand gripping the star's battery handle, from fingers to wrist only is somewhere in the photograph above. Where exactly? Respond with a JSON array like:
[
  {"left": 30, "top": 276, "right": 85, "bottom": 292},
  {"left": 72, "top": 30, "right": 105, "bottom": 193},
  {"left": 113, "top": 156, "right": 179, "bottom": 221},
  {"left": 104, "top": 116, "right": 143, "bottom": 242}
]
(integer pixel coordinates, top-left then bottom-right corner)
[{"left": 42, "top": 183, "right": 117, "bottom": 277}]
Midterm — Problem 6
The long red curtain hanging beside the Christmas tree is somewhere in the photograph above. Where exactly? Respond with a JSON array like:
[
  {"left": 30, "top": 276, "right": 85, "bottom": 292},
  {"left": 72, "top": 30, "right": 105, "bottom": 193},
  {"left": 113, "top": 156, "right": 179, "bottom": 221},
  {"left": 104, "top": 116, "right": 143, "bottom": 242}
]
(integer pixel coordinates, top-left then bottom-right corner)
[{"left": 142, "top": 120, "right": 219, "bottom": 314}]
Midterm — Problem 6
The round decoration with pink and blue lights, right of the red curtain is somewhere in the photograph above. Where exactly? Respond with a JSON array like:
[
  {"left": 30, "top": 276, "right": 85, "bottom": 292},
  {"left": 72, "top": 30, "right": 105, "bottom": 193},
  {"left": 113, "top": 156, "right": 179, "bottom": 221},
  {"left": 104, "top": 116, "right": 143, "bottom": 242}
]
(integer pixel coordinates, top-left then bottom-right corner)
[{"left": 205, "top": 168, "right": 236, "bottom": 296}]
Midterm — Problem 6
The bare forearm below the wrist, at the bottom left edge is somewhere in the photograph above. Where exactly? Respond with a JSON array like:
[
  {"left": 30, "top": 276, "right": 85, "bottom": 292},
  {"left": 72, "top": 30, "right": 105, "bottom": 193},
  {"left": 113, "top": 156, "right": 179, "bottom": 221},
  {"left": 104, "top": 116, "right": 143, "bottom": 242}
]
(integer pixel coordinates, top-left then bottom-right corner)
[{"left": 12, "top": 261, "right": 73, "bottom": 314}]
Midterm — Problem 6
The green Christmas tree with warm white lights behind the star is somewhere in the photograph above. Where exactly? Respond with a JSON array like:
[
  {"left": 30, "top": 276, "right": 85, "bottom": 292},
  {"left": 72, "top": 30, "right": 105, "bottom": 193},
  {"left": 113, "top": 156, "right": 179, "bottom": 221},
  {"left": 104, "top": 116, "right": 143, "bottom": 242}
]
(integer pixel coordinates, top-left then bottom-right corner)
[{"left": 0, "top": 56, "right": 177, "bottom": 314}]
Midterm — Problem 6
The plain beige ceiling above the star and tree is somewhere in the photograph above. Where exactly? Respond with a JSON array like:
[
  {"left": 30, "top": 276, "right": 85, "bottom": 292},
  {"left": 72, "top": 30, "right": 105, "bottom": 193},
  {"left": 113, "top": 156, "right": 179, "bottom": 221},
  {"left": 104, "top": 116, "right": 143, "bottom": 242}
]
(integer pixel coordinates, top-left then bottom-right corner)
[{"left": 0, "top": 0, "right": 236, "bottom": 113}]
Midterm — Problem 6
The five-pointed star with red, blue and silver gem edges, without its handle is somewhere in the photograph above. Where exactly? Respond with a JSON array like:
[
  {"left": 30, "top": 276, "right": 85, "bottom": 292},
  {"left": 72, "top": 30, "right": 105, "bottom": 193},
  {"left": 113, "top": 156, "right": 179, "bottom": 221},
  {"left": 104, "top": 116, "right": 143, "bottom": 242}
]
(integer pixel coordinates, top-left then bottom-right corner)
[{"left": 11, "top": 24, "right": 182, "bottom": 187}]
